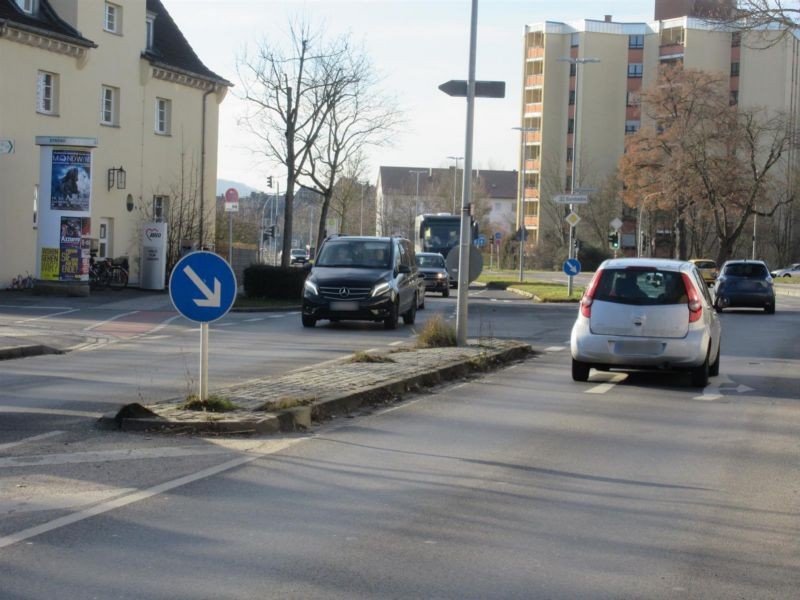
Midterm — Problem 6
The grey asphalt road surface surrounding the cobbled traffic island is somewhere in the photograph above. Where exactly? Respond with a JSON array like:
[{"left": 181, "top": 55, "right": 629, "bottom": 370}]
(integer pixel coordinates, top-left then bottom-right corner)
[{"left": 0, "top": 292, "right": 800, "bottom": 600}]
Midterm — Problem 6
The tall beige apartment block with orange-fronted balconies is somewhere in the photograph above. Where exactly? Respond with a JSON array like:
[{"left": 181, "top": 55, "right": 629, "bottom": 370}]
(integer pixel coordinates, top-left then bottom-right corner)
[{"left": 517, "top": 0, "right": 800, "bottom": 254}]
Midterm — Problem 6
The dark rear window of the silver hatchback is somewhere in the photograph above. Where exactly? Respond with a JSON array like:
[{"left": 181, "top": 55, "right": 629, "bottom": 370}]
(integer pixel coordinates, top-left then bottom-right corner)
[{"left": 594, "top": 267, "right": 689, "bottom": 306}]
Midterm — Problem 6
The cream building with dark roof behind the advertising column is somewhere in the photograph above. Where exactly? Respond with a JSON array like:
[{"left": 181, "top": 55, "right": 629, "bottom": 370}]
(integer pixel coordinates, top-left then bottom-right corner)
[{"left": 0, "top": 0, "right": 230, "bottom": 286}]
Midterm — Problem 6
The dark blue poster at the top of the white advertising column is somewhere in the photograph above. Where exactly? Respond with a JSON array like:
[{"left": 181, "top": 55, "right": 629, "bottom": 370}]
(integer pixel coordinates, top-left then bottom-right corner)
[{"left": 50, "top": 149, "right": 92, "bottom": 212}]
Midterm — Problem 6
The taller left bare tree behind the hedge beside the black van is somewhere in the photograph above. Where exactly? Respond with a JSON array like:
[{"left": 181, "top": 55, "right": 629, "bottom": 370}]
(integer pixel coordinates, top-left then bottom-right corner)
[{"left": 237, "top": 20, "right": 352, "bottom": 267}]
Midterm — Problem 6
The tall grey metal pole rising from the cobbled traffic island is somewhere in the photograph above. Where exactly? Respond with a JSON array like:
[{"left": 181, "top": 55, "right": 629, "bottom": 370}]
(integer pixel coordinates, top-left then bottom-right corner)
[{"left": 456, "top": 0, "right": 478, "bottom": 346}]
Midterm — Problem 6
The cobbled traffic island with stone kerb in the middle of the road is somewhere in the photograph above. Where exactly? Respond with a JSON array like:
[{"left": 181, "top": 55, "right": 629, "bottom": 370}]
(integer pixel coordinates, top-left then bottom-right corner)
[{"left": 100, "top": 339, "right": 533, "bottom": 434}]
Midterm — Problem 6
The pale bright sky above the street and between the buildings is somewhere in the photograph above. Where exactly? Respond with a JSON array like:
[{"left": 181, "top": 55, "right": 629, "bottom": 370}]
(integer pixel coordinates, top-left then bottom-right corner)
[{"left": 162, "top": 0, "right": 653, "bottom": 189}]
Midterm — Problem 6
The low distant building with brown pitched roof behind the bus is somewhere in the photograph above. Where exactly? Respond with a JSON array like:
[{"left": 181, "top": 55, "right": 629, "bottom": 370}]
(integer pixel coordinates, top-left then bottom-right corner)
[{"left": 375, "top": 167, "right": 518, "bottom": 237}]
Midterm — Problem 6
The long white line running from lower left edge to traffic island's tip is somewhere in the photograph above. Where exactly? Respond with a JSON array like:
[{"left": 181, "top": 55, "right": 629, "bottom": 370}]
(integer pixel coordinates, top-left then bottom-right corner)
[{"left": 0, "top": 438, "right": 304, "bottom": 548}]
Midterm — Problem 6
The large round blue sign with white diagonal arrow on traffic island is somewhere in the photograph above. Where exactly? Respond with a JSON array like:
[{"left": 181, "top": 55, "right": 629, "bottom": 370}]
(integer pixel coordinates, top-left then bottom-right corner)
[{"left": 169, "top": 252, "right": 236, "bottom": 323}]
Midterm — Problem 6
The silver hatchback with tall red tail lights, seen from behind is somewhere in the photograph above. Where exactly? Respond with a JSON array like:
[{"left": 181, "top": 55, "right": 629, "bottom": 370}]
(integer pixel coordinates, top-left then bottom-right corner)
[{"left": 570, "top": 258, "right": 721, "bottom": 387}]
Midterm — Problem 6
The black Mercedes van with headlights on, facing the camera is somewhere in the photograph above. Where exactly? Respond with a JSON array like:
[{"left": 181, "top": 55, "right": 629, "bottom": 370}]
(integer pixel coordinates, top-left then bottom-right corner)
[{"left": 302, "top": 236, "right": 420, "bottom": 329}]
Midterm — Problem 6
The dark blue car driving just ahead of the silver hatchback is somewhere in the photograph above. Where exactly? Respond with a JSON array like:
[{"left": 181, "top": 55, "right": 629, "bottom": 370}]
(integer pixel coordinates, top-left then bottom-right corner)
[{"left": 714, "top": 260, "right": 775, "bottom": 315}]
